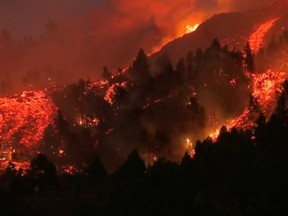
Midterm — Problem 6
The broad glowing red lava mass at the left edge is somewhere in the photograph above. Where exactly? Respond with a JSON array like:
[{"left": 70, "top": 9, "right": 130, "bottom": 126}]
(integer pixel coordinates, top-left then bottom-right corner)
[{"left": 0, "top": 90, "right": 56, "bottom": 164}]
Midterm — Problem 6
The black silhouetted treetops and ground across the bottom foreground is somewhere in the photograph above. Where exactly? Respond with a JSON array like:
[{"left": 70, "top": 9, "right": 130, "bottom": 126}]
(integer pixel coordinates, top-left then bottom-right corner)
[{"left": 0, "top": 86, "right": 288, "bottom": 215}]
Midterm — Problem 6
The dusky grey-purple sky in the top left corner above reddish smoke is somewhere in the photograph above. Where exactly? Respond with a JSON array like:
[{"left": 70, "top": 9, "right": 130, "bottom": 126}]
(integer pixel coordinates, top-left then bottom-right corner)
[{"left": 0, "top": 0, "right": 104, "bottom": 36}]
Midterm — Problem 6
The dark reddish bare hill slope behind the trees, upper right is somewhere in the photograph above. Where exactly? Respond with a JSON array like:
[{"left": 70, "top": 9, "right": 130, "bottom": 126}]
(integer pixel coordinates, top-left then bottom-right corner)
[{"left": 150, "top": 1, "right": 288, "bottom": 68}]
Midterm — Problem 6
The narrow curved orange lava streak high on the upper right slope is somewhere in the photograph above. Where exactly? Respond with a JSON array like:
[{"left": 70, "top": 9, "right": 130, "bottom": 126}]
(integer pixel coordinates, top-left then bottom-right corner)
[{"left": 249, "top": 17, "right": 280, "bottom": 53}]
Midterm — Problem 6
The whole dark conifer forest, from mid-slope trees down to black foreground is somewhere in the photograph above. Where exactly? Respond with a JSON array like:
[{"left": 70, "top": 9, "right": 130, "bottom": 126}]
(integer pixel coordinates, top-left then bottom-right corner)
[{"left": 0, "top": 33, "right": 288, "bottom": 216}]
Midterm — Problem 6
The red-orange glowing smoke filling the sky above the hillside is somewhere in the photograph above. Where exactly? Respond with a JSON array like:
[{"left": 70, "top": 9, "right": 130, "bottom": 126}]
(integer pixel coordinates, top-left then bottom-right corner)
[{"left": 0, "top": 0, "right": 270, "bottom": 94}]
